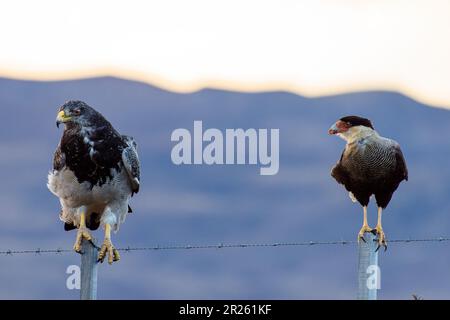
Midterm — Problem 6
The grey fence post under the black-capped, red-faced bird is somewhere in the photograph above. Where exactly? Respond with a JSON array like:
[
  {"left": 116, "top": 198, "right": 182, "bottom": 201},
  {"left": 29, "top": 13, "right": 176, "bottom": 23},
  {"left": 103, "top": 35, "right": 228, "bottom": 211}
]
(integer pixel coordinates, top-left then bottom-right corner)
[{"left": 357, "top": 232, "right": 381, "bottom": 300}]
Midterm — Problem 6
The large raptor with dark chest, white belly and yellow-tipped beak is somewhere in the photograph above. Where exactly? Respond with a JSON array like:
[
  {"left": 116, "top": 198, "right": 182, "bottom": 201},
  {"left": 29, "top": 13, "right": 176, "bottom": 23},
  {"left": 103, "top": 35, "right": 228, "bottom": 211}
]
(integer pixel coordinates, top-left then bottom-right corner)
[{"left": 47, "top": 101, "right": 140, "bottom": 263}]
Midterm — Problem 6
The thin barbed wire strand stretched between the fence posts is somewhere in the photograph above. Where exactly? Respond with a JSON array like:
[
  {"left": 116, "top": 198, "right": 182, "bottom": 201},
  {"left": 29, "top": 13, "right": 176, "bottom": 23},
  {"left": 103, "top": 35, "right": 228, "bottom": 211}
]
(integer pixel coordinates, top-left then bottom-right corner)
[{"left": 0, "top": 236, "right": 450, "bottom": 256}]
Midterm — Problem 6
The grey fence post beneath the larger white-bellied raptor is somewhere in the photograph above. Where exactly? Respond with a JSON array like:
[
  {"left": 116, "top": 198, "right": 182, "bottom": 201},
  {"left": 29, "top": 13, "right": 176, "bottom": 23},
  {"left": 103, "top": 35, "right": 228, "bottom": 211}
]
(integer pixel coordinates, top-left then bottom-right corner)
[{"left": 80, "top": 239, "right": 98, "bottom": 300}]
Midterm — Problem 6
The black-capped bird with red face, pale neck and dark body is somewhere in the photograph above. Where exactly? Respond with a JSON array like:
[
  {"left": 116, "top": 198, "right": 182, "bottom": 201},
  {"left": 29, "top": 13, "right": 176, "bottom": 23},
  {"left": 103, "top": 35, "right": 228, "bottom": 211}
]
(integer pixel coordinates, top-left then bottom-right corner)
[{"left": 328, "top": 116, "right": 408, "bottom": 250}]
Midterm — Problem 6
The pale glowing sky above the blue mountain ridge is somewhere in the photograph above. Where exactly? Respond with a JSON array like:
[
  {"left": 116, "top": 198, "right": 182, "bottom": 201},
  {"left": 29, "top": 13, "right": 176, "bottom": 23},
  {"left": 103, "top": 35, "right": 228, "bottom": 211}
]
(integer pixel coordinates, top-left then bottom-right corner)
[{"left": 0, "top": 0, "right": 450, "bottom": 107}]
